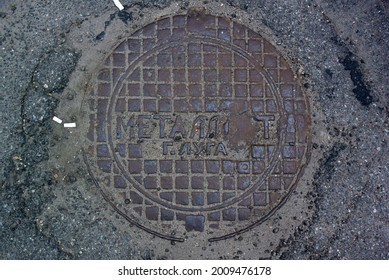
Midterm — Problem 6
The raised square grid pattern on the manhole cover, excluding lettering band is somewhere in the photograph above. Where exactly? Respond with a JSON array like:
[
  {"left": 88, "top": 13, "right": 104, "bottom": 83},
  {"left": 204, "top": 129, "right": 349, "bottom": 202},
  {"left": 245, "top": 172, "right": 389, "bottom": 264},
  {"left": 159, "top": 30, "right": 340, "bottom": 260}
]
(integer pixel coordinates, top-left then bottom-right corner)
[{"left": 88, "top": 16, "right": 306, "bottom": 225}]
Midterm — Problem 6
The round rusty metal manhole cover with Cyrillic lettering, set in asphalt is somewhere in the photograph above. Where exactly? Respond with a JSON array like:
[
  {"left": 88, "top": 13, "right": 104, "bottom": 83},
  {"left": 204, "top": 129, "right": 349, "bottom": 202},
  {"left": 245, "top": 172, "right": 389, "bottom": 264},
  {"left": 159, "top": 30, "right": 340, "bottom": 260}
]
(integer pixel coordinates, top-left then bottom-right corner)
[{"left": 85, "top": 15, "right": 310, "bottom": 241}]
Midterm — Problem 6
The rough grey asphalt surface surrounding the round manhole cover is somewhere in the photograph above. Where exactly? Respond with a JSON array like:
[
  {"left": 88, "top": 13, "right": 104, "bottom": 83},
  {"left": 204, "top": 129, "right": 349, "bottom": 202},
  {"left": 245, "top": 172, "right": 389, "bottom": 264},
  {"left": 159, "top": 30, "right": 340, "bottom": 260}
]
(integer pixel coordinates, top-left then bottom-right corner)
[{"left": 0, "top": 0, "right": 389, "bottom": 259}]
